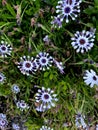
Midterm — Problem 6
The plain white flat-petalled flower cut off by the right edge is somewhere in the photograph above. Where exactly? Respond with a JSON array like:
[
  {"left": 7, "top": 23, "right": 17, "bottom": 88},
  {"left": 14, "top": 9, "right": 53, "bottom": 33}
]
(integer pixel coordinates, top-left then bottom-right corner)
[{"left": 83, "top": 69, "right": 98, "bottom": 88}]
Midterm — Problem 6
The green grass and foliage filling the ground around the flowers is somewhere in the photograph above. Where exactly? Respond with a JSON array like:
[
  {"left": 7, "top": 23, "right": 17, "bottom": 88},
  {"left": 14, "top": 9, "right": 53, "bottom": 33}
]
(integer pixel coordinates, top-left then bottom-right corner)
[{"left": 0, "top": 0, "right": 98, "bottom": 130}]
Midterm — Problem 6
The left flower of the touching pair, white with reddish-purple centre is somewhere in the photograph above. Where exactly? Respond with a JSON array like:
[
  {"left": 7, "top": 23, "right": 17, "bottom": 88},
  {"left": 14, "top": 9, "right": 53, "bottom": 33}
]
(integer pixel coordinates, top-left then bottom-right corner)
[{"left": 18, "top": 56, "right": 37, "bottom": 76}]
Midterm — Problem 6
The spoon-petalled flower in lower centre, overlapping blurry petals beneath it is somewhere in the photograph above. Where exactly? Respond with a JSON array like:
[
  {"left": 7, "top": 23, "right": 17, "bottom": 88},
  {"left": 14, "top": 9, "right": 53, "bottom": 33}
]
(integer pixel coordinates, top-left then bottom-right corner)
[{"left": 35, "top": 87, "right": 58, "bottom": 111}]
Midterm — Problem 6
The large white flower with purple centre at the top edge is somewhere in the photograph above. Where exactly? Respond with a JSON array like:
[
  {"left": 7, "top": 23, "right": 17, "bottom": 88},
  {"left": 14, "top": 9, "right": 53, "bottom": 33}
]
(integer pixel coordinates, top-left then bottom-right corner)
[{"left": 56, "top": 0, "right": 81, "bottom": 23}]
